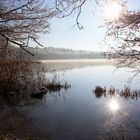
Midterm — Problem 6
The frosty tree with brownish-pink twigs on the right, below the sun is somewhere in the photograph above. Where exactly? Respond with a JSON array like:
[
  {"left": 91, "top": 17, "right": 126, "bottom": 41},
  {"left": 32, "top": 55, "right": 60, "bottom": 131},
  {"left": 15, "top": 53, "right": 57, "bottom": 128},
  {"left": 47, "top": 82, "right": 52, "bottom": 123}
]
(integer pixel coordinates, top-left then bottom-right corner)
[{"left": 105, "top": 2, "right": 140, "bottom": 67}]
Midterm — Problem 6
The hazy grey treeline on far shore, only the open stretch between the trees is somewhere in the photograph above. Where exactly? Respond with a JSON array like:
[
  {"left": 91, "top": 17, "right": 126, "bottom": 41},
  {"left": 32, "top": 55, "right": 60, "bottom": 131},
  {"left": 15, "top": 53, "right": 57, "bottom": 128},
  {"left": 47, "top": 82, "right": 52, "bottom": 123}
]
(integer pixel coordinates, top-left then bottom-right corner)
[{"left": 30, "top": 47, "right": 105, "bottom": 60}]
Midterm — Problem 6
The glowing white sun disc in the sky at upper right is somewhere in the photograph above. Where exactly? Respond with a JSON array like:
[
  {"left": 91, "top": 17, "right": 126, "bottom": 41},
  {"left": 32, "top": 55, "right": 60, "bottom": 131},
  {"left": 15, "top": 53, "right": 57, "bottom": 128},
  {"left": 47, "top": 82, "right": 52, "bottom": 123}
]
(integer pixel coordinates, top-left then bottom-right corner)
[{"left": 103, "top": 2, "right": 122, "bottom": 20}]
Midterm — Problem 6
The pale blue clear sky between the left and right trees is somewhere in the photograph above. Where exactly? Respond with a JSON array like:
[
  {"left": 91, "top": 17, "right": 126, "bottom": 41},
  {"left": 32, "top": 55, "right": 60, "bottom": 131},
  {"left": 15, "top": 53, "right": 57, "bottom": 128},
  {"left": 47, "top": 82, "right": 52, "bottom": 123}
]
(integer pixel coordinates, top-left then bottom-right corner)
[{"left": 40, "top": 0, "right": 140, "bottom": 51}]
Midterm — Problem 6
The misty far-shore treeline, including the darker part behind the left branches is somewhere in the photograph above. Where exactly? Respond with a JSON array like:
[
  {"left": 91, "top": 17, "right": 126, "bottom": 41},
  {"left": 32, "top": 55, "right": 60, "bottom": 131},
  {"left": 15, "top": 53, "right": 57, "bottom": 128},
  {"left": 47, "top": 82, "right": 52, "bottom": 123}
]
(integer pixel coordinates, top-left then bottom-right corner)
[{"left": 0, "top": 47, "right": 105, "bottom": 60}]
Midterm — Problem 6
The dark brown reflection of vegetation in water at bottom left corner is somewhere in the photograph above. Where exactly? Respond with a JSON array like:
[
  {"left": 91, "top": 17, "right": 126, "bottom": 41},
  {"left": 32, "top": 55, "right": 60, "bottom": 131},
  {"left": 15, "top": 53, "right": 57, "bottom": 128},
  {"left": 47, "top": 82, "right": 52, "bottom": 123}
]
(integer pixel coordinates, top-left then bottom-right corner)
[{"left": 0, "top": 94, "right": 50, "bottom": 140}]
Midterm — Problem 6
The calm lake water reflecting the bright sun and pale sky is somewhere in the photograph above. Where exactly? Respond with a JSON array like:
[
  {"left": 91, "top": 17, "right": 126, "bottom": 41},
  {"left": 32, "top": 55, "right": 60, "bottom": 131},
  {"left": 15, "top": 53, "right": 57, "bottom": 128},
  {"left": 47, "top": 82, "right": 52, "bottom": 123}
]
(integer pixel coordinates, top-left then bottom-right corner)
[{"left": 0, "top": 60, "right": 140, "bottom": 140}]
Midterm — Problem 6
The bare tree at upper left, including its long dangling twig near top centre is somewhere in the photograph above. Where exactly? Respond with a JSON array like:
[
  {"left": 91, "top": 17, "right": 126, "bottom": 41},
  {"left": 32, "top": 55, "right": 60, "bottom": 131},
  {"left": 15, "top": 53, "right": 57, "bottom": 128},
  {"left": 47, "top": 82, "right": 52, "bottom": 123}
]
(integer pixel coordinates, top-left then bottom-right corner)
[{"left": 0, "top": 0, "right": 86, "bottom": 55}]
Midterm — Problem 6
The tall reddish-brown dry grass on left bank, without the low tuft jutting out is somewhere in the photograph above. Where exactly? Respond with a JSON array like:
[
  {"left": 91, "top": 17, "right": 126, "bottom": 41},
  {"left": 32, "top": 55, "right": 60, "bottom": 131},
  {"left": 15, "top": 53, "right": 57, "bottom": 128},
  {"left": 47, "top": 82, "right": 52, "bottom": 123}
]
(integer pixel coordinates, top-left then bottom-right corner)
[{"left": 0, "top": 58, "right": 44, "bottom": 104}]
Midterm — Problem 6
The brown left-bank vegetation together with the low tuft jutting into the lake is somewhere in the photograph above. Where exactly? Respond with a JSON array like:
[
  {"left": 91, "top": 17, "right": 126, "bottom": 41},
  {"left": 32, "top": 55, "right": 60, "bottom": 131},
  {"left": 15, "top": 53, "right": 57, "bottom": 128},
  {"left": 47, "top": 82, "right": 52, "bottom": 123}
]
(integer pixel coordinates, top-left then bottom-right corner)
[{"left": 0, "top": 56, "right": 70, "bottom": 105}]
